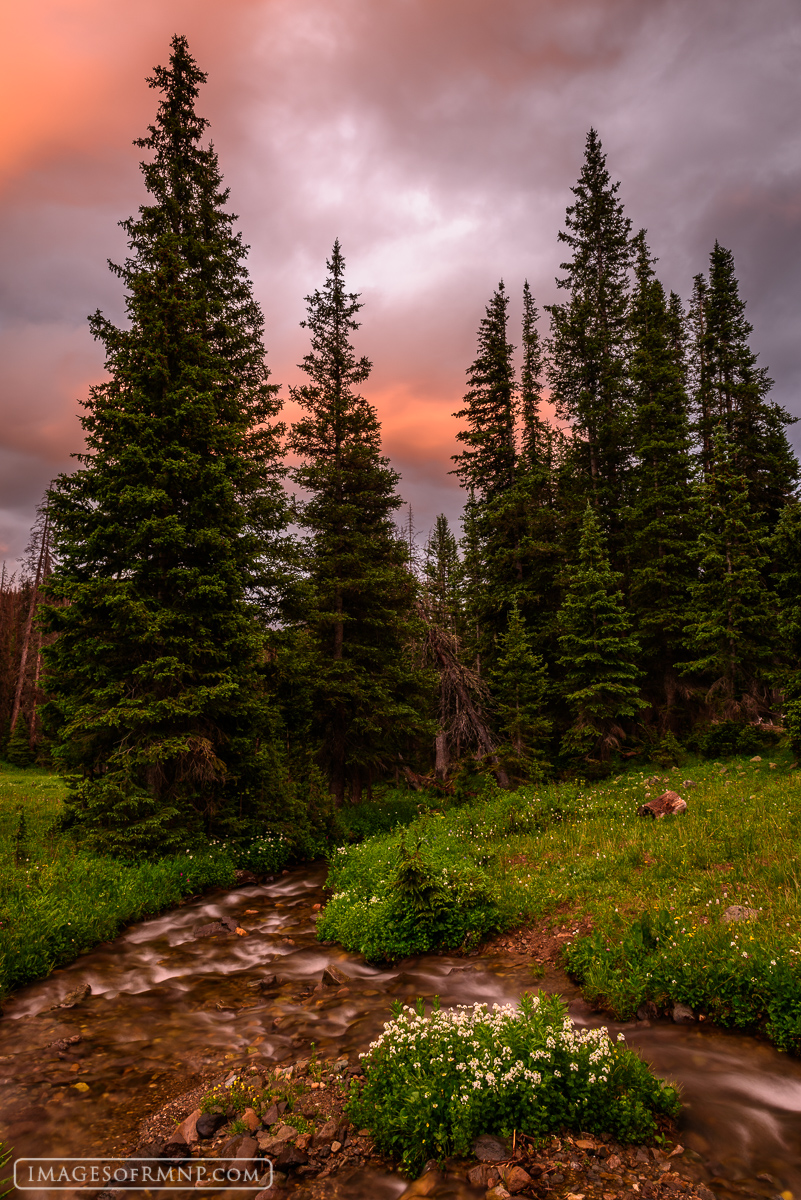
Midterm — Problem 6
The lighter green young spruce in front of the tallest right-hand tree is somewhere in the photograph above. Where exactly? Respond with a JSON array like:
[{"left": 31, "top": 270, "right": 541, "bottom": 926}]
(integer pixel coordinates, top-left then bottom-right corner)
[{"left": 558, "top": 503, "right": 645, "bottom": 758}]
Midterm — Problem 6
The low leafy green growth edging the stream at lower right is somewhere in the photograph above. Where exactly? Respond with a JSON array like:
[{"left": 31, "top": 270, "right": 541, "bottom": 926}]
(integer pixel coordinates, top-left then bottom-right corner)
[{"left": 566, "top": 910, "right": 801, "bottom": 1052}]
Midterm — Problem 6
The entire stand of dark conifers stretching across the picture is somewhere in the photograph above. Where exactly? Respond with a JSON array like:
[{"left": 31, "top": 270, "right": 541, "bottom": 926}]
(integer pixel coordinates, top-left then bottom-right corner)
[{"left": 0, "top": 36, "right": 801, "bottom": 856}]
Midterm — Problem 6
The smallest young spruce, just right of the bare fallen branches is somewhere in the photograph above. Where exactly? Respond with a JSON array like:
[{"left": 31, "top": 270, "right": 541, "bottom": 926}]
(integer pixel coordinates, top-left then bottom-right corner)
[{"left": 490, "top": 601, "right": 552, "bottom": 782}]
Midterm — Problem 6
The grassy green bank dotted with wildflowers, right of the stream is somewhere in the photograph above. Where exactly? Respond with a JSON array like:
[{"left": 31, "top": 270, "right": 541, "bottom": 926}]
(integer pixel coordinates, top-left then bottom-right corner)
[{"left": 318, "top": 751, "right": 801, "bottom": 1050}]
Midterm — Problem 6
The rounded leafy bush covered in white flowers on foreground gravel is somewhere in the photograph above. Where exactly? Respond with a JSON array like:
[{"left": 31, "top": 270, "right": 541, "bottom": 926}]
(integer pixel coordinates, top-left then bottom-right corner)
[{"left": 347, "top": 994, "right": 680, "bottom": 1171}]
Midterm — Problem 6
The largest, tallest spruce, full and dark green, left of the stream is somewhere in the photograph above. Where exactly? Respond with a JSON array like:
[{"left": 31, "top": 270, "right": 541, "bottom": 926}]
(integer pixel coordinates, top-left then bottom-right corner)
[{"left": 46, "top": 36, "right": 284, "bottom": 853}]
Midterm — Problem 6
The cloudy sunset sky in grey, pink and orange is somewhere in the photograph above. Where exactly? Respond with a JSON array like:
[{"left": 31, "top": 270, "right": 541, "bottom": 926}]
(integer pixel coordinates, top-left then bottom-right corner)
[{"left": 0, "top": 0, "right": 801, "bottom": 566}]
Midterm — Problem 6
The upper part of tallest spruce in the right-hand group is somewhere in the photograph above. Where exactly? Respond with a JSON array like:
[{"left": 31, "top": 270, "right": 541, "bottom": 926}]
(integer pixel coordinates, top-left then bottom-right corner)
[{"left": 548, "top": 130, "right": 632, "bottom": 559}]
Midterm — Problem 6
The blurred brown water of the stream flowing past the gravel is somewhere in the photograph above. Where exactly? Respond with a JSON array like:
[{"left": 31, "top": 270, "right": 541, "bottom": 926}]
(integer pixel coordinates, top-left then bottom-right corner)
[{"left": 0, "top": 868, "right": 801, "bottom": 1200}]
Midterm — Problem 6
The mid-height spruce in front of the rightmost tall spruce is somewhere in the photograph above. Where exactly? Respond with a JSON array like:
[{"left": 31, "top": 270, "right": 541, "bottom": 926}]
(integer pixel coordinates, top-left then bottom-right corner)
[{"left": 679, "top": 427, "right": 775, "bottom": 720}]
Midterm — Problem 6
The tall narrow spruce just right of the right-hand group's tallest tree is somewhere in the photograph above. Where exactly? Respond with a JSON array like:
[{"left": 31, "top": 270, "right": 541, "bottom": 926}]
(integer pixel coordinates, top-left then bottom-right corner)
[{"left": 626, "top": 232, "right": 697, "bottom": 721}]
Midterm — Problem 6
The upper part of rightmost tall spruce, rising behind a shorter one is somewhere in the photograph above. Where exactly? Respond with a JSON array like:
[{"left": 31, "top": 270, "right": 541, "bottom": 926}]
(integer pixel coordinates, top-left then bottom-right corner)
[{"left": 694, "top": 242, "right": 799, "bottom": 529}]
